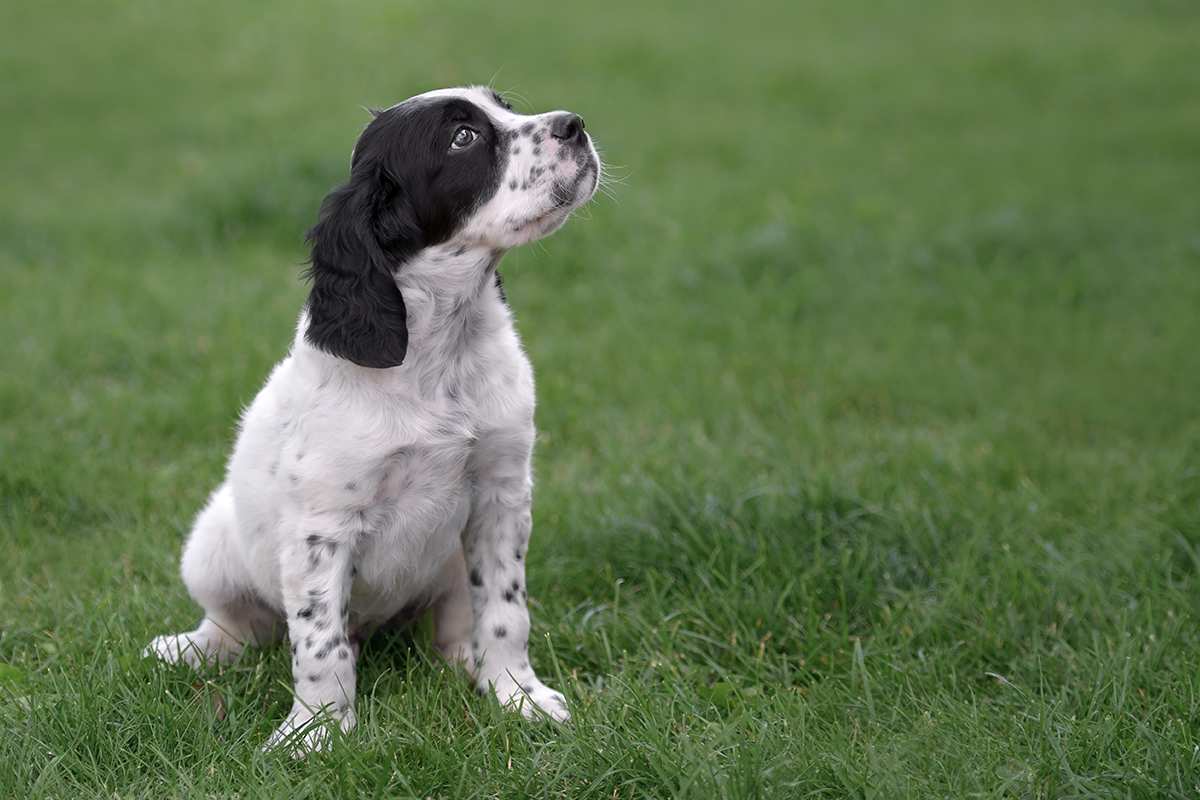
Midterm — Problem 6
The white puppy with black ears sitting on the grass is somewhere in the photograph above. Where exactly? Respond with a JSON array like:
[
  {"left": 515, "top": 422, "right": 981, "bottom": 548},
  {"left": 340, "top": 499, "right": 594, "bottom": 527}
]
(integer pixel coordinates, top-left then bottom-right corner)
[{"left": 146, "top": 88, "right": 600, "bottom": 753}]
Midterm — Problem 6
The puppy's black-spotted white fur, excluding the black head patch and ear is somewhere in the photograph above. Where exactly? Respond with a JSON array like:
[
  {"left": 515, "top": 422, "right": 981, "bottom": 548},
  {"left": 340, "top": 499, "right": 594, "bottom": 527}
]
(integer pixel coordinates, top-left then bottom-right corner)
[{"left": 146, "top": 88, "right": 599, "bottom": 753}]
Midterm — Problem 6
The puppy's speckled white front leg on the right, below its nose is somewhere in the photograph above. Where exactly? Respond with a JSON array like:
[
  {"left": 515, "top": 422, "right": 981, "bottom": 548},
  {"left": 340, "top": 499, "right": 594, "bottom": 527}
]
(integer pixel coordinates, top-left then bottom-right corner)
[{"left": 463, "top": 427, "right": 570, "bottom": 721}]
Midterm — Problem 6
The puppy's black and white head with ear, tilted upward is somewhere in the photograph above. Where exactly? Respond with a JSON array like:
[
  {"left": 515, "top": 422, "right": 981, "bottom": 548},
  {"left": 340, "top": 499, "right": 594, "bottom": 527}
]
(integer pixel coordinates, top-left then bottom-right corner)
[{"left": 306, "top": 88, "right": 600, "bottom": 368}]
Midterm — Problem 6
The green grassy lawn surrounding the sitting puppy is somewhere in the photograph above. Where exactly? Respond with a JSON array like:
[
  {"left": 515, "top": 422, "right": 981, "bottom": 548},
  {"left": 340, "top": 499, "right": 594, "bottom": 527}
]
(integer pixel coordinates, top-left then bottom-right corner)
[{"left": 0, "top": 0, "right": 1200, "bottom": 800}]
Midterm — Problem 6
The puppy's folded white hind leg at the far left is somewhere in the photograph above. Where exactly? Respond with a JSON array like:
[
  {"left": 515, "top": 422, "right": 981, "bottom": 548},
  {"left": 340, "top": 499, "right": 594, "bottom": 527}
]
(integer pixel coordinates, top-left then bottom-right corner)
[{"left": 143, "top": 485, "right": 283, "bottom": 667}]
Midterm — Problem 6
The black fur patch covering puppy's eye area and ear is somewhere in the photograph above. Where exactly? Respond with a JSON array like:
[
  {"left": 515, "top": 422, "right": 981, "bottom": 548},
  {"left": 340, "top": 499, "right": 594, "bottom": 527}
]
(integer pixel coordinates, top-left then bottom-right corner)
[{"left": 305, "top": 97, "right": 508, "bottom": 368}]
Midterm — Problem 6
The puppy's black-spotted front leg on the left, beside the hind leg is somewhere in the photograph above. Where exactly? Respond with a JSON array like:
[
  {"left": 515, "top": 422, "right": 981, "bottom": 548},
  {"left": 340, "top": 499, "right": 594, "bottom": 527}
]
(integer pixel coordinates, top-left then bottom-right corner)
[{"left": 264, "top": 518, "right": 355, "bottom": 756}]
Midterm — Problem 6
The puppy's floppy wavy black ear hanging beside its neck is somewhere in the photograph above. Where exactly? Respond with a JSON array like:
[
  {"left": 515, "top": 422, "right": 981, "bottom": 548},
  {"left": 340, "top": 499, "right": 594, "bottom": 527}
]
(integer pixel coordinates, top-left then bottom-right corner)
[{"left": 306, "top": 169, "right": 419, "bottom": 368}]
